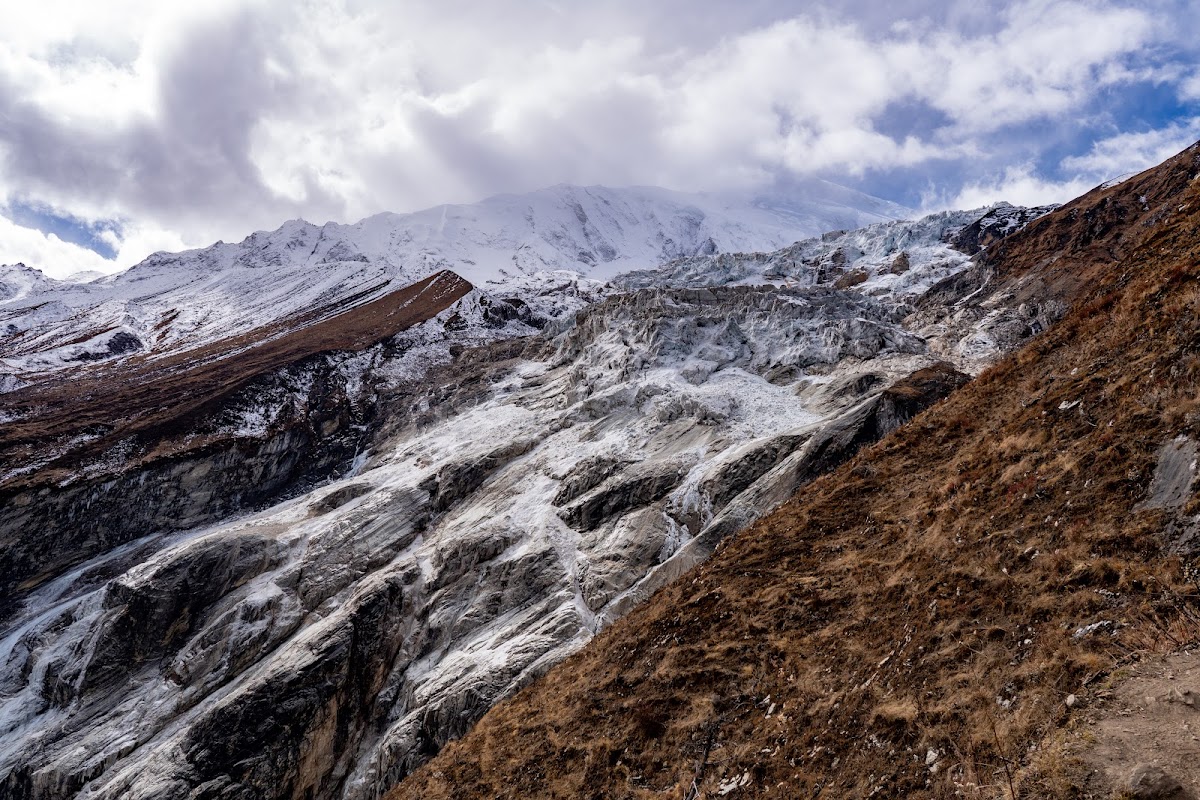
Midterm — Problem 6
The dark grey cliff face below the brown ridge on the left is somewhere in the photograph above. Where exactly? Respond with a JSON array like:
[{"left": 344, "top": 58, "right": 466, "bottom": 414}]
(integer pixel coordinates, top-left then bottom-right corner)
[{"left": 0, "top": 361, "right": 360, "bottom": 612}]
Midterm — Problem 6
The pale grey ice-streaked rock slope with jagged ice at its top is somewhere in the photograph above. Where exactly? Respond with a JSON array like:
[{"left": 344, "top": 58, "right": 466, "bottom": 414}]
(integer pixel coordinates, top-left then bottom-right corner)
[{"left": 0, "top": 287, "right": 969, "bottom": 799}]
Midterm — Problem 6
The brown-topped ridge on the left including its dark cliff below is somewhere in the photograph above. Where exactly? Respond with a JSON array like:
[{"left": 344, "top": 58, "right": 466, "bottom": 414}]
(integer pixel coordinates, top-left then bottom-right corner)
[{"left": 0, "top": 273, "right": 477, "bottom": 619}]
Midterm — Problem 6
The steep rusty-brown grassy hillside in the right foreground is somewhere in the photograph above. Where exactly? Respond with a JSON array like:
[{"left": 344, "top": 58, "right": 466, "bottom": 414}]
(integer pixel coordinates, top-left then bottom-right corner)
[{"left": 390, "top": 145, "right": 1200, "bottom": 799}]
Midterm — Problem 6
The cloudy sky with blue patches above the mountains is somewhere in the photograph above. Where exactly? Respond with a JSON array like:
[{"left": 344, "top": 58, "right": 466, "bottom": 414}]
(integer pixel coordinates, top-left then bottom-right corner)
[{"left": 0, "top": 0, "right": 1200, "bottom": 277}]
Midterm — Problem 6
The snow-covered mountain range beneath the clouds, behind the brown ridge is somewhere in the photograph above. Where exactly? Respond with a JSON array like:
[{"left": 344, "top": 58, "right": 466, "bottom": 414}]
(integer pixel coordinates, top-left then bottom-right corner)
[{"left": 0, "top": 181, "right": 912, "bottom": 389}]
